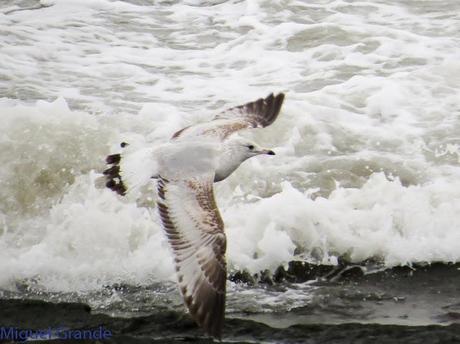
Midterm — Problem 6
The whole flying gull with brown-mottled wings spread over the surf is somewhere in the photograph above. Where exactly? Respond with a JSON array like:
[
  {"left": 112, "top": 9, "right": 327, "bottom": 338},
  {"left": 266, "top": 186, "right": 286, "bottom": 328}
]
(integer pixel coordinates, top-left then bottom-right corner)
[{"left": 103, "top": 93, "right": 284, "bottom": 339}]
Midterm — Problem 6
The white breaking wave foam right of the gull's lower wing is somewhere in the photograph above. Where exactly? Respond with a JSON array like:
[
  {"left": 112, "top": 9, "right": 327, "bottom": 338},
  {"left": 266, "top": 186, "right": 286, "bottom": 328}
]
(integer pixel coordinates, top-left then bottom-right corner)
[{"left": 224, "top": 173, "right": 460, "bottom": 272}]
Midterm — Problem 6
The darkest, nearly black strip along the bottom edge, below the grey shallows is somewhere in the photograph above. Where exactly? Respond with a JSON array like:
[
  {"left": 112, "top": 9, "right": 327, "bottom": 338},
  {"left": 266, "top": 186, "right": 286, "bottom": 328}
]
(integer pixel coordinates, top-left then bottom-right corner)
[{"left": 0, "top": 300, "right": 460, "bottom": 344}]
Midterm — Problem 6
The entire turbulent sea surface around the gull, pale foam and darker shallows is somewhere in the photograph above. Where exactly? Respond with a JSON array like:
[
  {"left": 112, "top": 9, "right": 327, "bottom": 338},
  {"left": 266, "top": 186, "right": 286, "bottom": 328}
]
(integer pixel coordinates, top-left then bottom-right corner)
[{"left": 0, "top": 0, "right": 460, "bottom": 343}]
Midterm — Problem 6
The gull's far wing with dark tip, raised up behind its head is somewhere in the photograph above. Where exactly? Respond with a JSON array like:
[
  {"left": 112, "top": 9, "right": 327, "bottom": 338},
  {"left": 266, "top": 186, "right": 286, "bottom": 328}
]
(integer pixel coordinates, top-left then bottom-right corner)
[{"left": 173, "top": 93, "right": 284, "bottom": 140}]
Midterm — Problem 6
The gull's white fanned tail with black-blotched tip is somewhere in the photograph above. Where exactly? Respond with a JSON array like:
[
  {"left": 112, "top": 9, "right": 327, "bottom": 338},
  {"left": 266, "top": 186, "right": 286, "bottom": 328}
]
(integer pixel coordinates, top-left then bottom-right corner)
[{"left": 103, "top": 142, "right": 157, "bottom": 196}]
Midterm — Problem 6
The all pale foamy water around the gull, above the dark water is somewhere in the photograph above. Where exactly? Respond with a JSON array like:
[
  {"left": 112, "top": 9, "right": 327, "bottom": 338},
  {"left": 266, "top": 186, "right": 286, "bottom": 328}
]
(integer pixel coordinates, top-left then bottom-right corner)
[{"left": 0, "top": 0, "right": 460, "bottom": 291}]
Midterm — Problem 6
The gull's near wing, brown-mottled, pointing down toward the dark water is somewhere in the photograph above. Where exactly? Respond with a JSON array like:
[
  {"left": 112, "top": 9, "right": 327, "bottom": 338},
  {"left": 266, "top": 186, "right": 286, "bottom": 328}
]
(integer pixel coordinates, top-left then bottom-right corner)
[{"left": 158, "top": 175, "right": 227, "bottom": 338}]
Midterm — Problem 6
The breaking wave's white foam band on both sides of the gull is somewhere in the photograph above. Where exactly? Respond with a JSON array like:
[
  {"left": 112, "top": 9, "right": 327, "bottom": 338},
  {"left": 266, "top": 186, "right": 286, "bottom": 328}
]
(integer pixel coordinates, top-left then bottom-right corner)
[{"left": 0, "top": 95, "right": 460, "bottom": 291}]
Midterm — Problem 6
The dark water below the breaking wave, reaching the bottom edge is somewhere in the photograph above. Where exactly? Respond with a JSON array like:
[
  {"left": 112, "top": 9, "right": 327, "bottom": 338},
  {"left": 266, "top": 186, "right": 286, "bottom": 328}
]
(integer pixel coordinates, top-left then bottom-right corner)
[{"left": 0, "top": 263, "right": 460, "bottom": 344}]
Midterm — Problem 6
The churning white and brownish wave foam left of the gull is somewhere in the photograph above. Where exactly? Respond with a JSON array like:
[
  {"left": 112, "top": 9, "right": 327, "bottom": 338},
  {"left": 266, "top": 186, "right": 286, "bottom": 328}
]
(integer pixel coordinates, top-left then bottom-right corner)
[{"left": 0, "top": 99, "right": 177, "bottom": 290}]
